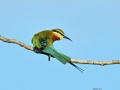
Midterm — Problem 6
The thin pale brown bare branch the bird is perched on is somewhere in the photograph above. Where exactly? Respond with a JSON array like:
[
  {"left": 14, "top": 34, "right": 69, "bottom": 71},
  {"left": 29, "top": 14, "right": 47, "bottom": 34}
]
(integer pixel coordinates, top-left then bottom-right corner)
[{"left": 0, "top": 35, "right": 120, "bottom": 66}]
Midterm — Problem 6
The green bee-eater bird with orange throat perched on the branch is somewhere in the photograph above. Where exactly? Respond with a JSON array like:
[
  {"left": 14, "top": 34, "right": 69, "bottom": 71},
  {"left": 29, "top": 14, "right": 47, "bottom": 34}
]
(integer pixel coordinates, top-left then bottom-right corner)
[{"left": 32, "top": 28, "right": 84, "bottom": 72}]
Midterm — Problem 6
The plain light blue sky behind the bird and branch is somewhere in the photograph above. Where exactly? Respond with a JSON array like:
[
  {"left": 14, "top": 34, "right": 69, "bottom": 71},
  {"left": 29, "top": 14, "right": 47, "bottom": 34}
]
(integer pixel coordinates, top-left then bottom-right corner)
[{"left": 0, "top": 0, "right": 120, "bottom": 90}]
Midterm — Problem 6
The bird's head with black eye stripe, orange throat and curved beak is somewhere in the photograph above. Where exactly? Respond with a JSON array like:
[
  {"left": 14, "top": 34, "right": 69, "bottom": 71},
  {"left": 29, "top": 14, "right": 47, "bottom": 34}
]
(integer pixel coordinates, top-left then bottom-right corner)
[{"left": 52, "top": 28, "right": 72, "bottom": 41}]
